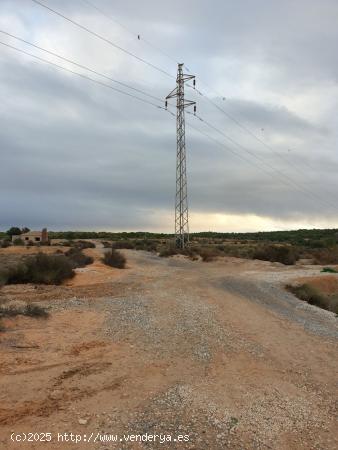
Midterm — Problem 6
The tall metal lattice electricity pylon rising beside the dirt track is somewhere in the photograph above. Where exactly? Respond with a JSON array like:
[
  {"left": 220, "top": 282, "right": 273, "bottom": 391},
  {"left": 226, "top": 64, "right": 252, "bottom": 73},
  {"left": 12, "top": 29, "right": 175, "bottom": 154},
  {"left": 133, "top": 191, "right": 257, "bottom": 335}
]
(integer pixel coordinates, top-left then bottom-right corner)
[{"left": 165, "top": 64, "right": 196, "bottom": 248}]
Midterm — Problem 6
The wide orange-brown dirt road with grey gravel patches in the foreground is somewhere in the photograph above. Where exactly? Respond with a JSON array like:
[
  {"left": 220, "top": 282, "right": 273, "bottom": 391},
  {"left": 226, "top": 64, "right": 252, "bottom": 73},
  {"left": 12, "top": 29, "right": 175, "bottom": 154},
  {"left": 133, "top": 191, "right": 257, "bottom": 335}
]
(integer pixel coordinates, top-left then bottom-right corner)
[{"left": 0, "top": 251, "right": 338, "bottom": 450}]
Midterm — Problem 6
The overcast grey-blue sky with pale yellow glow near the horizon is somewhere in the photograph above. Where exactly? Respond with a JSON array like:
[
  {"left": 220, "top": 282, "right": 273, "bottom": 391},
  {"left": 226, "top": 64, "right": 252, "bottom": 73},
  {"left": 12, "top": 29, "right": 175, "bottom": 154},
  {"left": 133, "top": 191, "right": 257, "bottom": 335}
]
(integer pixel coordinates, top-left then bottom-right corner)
[{"left": 0, "top": 0, "right": 338, "bottom": 232}]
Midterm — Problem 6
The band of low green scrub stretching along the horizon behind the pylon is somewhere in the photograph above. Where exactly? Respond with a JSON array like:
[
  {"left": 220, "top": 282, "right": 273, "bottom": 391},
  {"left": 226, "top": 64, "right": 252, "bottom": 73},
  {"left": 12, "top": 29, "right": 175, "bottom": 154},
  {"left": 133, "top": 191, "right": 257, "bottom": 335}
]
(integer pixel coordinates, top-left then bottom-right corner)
[{"left": 5, "top": 227, "right": 338, "bottom": 265}]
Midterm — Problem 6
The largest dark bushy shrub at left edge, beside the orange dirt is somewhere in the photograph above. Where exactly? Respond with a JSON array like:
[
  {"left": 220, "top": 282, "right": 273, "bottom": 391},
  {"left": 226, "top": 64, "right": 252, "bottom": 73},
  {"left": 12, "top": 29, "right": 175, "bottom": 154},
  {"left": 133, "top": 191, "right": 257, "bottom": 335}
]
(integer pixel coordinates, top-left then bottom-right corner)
[{"left": 0, "top": 253, "right": 74, "bottom": 284}]
